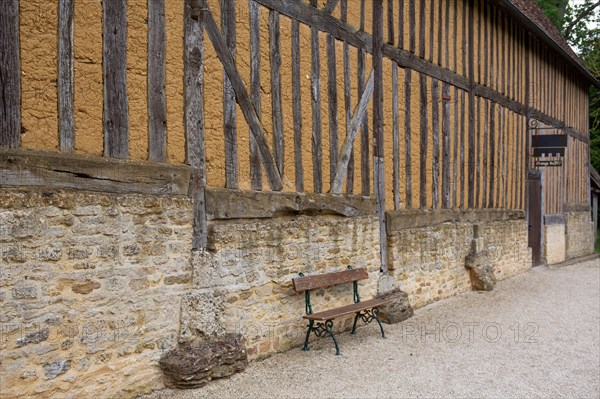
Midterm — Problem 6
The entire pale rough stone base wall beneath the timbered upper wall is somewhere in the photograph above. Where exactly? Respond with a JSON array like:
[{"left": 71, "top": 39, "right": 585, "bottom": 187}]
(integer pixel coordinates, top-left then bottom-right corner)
[{"left": 0, "top": 188, "right": 531, "bottom": 398}]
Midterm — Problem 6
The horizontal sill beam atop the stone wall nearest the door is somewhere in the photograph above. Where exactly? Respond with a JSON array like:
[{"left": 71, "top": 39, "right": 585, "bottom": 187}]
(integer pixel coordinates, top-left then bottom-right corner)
[{"left": 385, "top": 209, "right": 525, "bottom": 233}]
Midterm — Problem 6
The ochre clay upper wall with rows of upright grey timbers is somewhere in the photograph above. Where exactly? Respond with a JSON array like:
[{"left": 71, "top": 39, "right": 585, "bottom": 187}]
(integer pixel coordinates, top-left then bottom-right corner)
[{"left": 3, "top": 0, "right": 588, "bottom": 219}]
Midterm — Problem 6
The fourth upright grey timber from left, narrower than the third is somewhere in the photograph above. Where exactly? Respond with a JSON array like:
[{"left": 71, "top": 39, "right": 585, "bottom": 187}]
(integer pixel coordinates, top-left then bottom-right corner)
[{"left": 148, "top": 0, "right": 167, "bottom": 162}]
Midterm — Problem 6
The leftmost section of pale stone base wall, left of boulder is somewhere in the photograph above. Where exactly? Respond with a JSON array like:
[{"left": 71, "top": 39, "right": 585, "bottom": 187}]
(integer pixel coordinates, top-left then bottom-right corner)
[{"left": 0, "top": 189, "right": 192, "bottom": 398}]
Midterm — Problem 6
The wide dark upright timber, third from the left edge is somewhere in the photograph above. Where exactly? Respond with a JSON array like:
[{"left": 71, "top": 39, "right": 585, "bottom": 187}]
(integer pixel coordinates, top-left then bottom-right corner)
[{"left": 102, "top": 0, "right": 129, "bottom": 158}]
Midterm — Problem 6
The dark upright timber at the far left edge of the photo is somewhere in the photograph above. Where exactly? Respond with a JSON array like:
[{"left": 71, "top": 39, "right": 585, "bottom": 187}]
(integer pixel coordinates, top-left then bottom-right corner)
[{"left": 0, "top": 0, "right": 21, "bottom": 148}]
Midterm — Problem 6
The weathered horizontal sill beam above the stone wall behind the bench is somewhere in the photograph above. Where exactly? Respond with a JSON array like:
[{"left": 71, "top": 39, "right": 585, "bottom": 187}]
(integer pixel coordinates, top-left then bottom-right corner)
[{"left": 206, "top": 189, "right": 375, "bottom": 220}]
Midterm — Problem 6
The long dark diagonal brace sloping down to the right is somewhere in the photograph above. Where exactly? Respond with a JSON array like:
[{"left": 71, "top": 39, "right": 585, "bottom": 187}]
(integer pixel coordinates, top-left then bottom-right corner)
[{"left": 201, "top": 2, "right": 283, "bottom": 191}]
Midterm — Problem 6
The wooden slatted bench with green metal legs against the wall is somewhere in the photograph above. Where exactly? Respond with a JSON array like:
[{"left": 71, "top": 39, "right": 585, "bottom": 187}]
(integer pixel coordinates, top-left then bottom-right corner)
[{"left": 292, "top": 266, "right": 391, "bottom": 355}]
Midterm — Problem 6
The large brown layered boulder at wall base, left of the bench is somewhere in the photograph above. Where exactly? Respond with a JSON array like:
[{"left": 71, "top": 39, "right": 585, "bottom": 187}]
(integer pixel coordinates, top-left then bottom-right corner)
[{"left": 159, "top": 334, "right": 248, "bottom": 389}]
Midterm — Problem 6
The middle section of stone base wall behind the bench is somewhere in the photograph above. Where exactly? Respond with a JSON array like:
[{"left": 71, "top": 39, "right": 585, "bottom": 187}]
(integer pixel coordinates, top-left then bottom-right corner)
[{"left": 186, "top": 215, "right": 380, "bottom": 359}]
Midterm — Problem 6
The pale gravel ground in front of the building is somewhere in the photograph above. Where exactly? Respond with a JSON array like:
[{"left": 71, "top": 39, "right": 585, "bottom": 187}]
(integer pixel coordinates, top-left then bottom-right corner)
[{"left": 145, "top": 259, "right": 600, "bottom": 399}]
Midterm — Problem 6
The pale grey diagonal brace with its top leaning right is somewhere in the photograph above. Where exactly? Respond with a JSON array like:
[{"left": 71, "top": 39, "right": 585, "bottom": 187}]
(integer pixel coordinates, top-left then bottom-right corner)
[{"left": 330, "top": 71, "right": 374, "bottom": 194}]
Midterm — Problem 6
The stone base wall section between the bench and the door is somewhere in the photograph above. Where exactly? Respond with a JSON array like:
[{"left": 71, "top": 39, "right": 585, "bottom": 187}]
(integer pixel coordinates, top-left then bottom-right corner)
[{"left": 388, "top": 216, "right": 531, "bottom": 308}]
